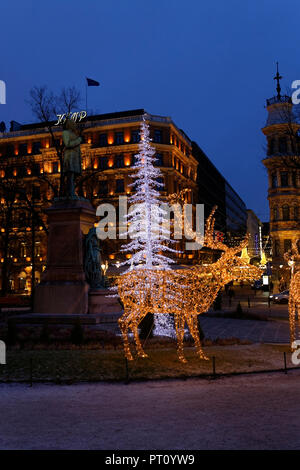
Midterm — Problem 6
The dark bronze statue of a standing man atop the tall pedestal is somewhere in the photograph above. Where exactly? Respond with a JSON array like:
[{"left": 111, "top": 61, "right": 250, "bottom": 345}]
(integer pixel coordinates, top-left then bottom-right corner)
[{"left": 62, "top": 119, "right": 82, "bottom": 199}]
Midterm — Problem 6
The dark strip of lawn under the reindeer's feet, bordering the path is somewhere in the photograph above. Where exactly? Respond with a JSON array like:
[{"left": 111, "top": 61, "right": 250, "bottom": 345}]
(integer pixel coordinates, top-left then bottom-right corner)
[{"left": 0, "top": 344, "right": 293, "bottom": 383}]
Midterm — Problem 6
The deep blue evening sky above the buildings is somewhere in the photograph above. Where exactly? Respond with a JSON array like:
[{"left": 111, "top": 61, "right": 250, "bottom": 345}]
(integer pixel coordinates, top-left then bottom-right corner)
[{"left": 0, "top": 0, "right": 300, "bottom": 220}]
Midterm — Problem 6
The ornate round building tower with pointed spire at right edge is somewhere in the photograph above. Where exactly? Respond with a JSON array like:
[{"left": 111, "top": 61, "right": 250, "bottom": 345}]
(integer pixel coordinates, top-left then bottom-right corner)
[{"left": 262, "top": 63, "right": 300, "bottom": 281}]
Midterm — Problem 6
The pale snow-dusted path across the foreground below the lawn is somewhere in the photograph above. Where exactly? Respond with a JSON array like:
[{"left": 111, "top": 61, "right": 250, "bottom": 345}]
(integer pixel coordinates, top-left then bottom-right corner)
[{"left": 0, "top": 371, "right": 300, "bottom": 450}]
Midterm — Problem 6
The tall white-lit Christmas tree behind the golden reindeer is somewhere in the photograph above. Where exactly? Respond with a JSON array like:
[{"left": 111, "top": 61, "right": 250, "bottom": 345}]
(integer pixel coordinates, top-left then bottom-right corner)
[{"left": 122, "top": 115, "right": 176, "bottom": 334}]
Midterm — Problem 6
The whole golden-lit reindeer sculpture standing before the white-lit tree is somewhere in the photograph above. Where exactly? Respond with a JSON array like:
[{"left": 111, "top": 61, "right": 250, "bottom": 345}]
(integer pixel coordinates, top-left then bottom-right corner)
[{"left": 117, "top": 207, "right": 261, "bottom": 362}]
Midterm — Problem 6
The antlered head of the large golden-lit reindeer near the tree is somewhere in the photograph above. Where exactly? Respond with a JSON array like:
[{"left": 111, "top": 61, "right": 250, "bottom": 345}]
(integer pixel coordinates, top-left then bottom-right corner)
[{"left": 204, "top": 206, "right": 263, "bottom": 284}]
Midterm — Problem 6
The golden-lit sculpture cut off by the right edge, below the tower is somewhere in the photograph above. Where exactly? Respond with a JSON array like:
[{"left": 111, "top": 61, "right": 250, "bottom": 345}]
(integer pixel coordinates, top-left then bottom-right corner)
[{"left": 284, "top": 239, "right": 300, "bottom": 351}]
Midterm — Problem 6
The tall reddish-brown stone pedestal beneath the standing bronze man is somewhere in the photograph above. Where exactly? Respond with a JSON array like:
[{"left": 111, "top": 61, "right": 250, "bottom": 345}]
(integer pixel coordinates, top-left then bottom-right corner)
[{"left": 34, "top": 199, "right": 95, "bottom": 314}]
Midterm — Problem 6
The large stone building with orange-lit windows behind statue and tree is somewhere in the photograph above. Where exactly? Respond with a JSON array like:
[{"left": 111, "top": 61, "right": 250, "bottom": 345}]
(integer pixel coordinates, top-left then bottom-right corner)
[{"left": 0, "top": 109, "right": 198, "bottom": 293}]
